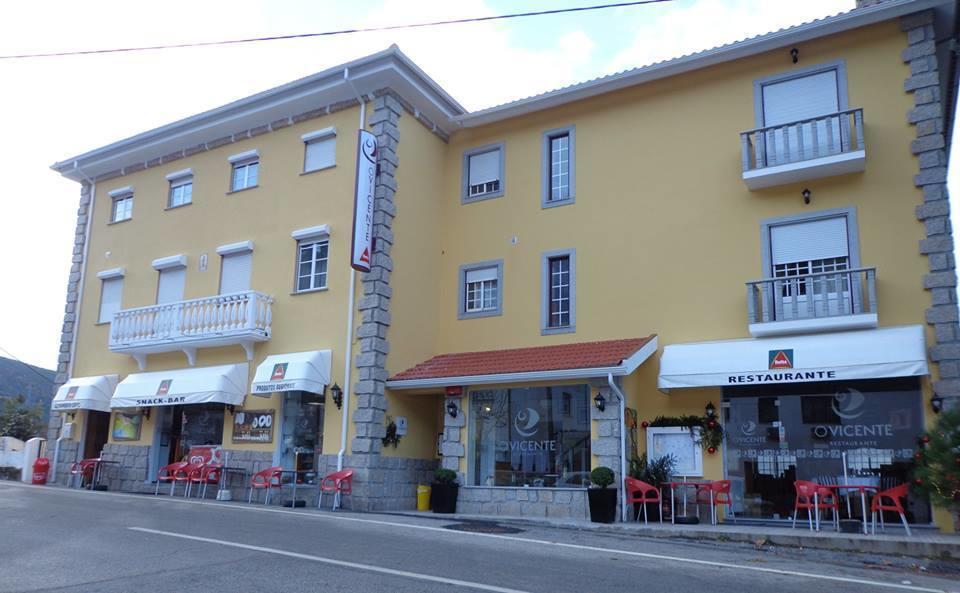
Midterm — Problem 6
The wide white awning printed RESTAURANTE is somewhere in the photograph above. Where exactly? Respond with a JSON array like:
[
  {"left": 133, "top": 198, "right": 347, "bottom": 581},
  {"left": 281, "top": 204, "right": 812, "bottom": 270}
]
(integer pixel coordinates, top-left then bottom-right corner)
[{"left": 657, "top": 325, "right": 929, "bottom": 390}]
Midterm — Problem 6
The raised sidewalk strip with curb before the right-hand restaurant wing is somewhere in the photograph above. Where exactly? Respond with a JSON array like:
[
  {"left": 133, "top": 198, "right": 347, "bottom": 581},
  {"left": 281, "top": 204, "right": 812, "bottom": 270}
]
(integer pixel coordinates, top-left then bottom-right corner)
[{"left": 392, "top": 511, "right": 960, "bottom": 560}]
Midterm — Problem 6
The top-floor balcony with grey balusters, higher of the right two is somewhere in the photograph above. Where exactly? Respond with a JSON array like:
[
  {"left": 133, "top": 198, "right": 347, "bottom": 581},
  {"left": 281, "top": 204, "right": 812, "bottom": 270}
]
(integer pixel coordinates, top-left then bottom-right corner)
[{"left": 740, "top": 109, "right": 866, "bottom": 190}]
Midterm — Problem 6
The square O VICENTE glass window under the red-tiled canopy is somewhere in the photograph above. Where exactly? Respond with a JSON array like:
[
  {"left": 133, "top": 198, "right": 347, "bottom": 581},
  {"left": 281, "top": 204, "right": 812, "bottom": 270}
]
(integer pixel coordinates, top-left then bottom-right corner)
[{"left": 469, "top": 385, "right": 590, "bottom": 488}]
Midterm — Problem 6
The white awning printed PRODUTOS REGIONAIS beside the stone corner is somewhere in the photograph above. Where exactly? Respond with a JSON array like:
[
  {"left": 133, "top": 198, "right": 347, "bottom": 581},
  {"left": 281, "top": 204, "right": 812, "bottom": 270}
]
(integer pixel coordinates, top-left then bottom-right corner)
[{"left": 250, "top": 350, "right": 332, "bottom": 397}]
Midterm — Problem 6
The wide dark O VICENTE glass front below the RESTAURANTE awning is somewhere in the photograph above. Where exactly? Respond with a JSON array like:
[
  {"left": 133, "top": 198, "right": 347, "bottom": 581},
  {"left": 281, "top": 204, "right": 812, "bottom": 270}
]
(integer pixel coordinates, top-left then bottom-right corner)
[{"left": 723, "top": 377, "right": 930, "bottom": 523}]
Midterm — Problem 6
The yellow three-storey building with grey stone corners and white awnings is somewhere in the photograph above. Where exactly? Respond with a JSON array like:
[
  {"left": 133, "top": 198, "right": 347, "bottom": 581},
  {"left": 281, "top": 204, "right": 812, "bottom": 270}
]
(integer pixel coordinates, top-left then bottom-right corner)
[{"left": 50, "top": 0, "right": 960, "bottom": 529}]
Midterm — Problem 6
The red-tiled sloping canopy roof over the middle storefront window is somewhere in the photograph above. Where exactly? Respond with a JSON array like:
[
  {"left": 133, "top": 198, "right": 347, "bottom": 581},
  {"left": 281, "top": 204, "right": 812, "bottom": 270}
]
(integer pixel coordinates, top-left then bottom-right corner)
[{"left": 389, "top": 335, "right": 656, "bottom": 381}]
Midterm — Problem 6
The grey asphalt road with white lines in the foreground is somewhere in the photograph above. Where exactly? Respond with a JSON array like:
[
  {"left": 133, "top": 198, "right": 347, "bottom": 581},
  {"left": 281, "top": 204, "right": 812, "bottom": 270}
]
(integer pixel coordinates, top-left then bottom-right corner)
[{"left": 0, "top": 482, "right": 960, "bottom": 593}]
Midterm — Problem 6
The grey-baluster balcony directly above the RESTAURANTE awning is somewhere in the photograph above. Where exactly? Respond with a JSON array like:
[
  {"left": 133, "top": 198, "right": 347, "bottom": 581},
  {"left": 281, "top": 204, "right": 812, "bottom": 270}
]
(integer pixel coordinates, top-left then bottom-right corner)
[{"left": 747, "top": 268, "right": 877, "bottom": 338}]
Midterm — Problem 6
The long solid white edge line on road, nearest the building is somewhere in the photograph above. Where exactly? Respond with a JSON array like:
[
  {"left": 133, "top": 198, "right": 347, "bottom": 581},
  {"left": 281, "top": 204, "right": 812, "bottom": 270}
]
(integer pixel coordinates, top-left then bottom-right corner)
[{"left": 13, "top": 484, "right": 949, "bottom": 593}]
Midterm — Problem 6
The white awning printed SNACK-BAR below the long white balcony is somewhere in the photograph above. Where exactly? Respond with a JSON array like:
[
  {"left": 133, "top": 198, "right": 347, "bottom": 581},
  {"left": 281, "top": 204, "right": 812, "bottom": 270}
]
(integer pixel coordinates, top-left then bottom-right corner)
[{"left": 110, "top": 362, "right": 249, "bottom": 408}]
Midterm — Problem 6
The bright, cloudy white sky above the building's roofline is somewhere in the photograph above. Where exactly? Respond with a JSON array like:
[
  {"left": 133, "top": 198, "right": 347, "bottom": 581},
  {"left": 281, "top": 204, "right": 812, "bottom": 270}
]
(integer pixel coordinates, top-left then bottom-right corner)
[{"left": 7, "top": 0, "right": 952, "bottom": 368}]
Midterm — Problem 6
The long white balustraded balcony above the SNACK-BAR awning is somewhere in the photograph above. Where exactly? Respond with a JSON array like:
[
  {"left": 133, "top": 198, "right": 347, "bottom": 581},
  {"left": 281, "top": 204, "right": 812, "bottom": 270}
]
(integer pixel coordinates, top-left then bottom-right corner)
[{"left": 110, "top": 290, "right": 273, "bottom": 370}]
